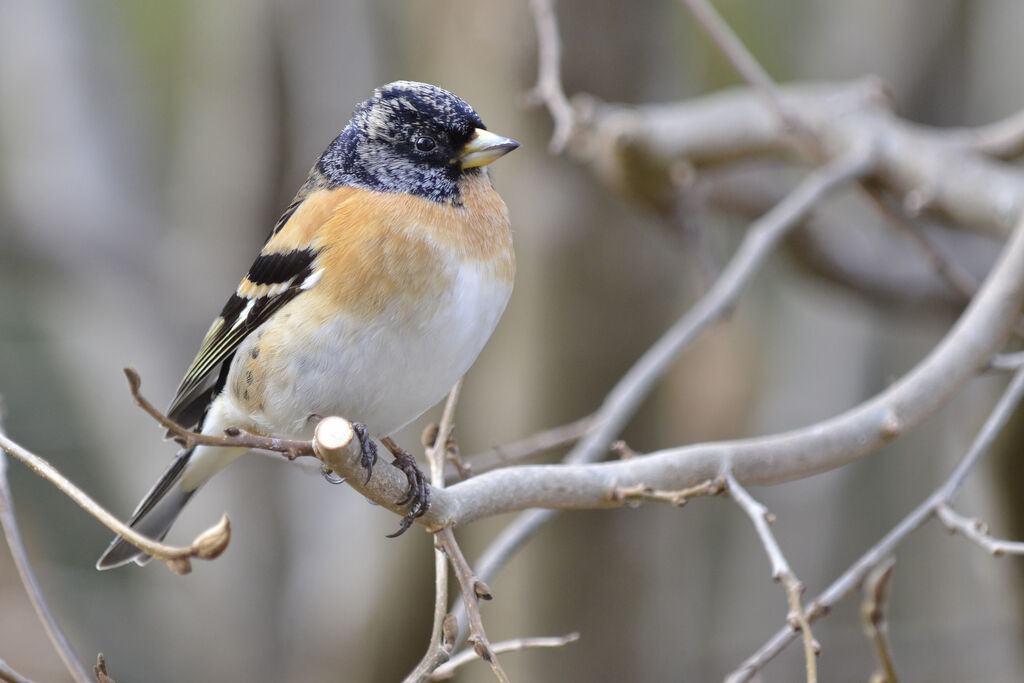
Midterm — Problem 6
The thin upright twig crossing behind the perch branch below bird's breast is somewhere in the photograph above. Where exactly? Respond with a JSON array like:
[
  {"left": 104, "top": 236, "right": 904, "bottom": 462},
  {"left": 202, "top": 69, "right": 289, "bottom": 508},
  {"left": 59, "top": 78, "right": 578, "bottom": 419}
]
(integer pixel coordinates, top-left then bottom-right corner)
[{"left": 404, "top": 380, "right": 462, "bottom": 683}]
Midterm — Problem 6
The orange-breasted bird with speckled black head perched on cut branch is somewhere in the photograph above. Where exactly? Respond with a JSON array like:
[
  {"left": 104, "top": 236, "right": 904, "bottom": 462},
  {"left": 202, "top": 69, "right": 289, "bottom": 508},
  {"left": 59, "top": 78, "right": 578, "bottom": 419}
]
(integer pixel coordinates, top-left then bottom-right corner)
[{"left": 96, "top": 81, "right": 519, "bottom": 569}]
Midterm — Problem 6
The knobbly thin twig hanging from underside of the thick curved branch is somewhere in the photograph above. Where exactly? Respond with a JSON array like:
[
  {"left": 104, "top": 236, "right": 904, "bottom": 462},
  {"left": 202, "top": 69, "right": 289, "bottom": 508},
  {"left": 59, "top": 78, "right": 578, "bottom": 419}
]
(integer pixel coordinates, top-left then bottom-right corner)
[{"left": 725, "top": 470, "right": 820, "bottom": 683}]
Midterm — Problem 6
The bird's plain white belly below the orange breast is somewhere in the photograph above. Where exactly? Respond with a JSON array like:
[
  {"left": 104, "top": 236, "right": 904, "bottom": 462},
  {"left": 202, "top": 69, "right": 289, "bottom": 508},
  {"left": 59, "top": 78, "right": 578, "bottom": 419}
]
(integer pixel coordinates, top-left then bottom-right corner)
[{"left": 226, "top": 264, "right": 511, "bottom": 438}]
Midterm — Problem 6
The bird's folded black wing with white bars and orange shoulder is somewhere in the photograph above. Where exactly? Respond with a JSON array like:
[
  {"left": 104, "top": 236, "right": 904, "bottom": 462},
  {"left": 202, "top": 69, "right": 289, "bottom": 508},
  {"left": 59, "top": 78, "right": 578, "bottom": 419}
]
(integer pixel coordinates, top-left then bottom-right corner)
[{"left": 167, "top": 182, "right": 356, "bottom": 427}]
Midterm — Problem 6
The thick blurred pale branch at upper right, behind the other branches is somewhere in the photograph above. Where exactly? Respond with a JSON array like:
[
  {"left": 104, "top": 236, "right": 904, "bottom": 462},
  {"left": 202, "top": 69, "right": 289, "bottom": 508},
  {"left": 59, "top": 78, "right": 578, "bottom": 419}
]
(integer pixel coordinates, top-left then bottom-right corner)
[{"left": 572, "top": 79, "right": 1024, "bottom": 236}]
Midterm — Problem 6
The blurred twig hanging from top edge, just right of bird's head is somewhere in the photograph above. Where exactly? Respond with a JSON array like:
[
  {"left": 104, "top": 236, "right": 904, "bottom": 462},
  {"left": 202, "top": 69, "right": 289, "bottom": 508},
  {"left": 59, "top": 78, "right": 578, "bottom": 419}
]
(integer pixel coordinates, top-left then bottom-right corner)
[{"left": 529, "top": 0, "right": 575, "bottom": 155}]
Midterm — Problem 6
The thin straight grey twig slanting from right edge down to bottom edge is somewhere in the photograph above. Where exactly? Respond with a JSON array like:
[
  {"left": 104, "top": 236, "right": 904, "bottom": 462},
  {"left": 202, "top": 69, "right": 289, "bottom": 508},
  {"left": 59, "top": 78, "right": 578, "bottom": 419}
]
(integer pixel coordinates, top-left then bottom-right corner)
[{"left": 727, "top": 368, "right": 1024, "bottom": 683}]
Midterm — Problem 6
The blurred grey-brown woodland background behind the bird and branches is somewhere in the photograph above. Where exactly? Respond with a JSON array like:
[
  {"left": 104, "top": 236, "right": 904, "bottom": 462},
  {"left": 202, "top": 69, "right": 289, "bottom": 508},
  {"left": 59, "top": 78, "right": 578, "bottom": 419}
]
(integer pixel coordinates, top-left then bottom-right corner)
[{"left": 0, "top": 0, "right": 1024, "bottom": 682}]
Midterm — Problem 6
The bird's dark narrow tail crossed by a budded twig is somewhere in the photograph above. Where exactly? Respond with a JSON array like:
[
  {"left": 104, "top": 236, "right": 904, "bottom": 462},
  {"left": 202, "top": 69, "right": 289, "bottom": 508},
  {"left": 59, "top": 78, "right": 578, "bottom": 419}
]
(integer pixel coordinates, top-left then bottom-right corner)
[{"left": 96, "top": 449, "right": 196, "bottom": 569}]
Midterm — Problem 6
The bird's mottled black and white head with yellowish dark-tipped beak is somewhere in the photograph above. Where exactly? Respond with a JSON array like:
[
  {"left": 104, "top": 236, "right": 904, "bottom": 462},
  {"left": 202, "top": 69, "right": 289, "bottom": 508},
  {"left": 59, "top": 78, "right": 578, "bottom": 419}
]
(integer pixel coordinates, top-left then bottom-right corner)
[{"left": 316, "top": 81, "right": 519, "bottom": 203}]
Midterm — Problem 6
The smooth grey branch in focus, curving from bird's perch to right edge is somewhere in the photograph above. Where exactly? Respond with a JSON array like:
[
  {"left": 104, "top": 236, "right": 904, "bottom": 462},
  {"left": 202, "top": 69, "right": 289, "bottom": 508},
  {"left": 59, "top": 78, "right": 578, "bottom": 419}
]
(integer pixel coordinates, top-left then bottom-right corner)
[{"left": 424, "top": 208, "right": 1024, "bottom": 526}]
